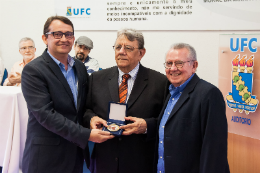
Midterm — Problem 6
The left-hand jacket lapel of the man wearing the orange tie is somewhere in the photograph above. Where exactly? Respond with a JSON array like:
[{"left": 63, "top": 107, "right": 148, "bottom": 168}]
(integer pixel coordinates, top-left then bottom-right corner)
[{"left": 108, "top": 66, "right": 119, "bottom": 102}]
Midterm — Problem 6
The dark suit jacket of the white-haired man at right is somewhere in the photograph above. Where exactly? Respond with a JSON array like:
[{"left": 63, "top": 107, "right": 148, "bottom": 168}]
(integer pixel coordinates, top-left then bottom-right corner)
[{"left": 154, "top": 74, "right": 229, "bottom": 173}]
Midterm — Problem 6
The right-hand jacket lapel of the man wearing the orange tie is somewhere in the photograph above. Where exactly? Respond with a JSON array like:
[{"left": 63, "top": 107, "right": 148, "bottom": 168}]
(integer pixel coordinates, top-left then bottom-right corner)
[{"left": 127, "top": 64, "right": 148, "bottom": 109}]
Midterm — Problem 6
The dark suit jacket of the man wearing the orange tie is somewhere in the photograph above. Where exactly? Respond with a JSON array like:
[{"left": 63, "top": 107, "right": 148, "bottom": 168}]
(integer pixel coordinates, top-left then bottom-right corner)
[{"left": 84, "top": 65, "right": 167, "bottom": 173}]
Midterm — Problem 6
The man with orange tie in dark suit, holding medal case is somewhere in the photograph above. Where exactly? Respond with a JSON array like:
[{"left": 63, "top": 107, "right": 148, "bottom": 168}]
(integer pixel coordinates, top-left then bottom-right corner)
[{"left": 84, "top": 29, "right": 167, "bottom": 173}]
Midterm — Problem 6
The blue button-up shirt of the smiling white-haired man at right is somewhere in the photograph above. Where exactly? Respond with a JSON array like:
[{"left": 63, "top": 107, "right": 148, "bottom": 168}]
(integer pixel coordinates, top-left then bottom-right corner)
[{"left": 157, "top": 74, "right": 194, "bottom": 173}]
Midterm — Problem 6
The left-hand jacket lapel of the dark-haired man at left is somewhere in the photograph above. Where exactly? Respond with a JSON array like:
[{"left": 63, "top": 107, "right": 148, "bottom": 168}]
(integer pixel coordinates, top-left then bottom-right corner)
[{"left": 43, "top": 49, "right": 74, "bottom": 108}]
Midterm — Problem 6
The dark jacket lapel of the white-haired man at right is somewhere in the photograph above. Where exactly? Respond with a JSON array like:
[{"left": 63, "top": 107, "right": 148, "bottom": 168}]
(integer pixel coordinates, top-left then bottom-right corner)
[{"left": 164, "top": 73, "right": 200, "bottom": 124}]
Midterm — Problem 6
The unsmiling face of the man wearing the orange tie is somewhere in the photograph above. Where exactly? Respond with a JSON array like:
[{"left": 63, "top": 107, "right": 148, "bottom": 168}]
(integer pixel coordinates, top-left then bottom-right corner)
[{"left": 115, "top": 35, "right": 145, "bottom": 73}]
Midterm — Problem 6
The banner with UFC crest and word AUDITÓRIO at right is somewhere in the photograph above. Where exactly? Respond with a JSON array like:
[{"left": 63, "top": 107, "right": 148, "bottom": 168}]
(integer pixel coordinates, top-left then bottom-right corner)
[{"left": 218, "top": 34, "right": 260, "bottom": 139}]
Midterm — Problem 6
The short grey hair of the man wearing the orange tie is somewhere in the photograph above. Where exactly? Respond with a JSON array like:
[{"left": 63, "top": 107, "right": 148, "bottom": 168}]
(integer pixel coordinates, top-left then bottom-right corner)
[{"left": 117, "top": 28, "right": 144, "bottom": 49}]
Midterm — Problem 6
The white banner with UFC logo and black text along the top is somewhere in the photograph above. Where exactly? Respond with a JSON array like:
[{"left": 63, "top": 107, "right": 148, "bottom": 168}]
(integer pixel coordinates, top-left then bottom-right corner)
[{"left": 55, "top": 0, "right": 260, "bottom": 30}]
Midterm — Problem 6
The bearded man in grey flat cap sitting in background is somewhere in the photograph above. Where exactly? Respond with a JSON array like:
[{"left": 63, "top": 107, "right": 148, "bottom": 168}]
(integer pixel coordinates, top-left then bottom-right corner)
[{"left": 74, "top": 36, "right": 99, "bottom": 75}]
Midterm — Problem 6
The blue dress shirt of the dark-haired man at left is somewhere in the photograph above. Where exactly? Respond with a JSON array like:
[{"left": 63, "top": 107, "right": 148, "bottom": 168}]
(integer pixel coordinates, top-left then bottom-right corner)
[{"left": 47, "top": 51, "right": 78, "bottom": 108}]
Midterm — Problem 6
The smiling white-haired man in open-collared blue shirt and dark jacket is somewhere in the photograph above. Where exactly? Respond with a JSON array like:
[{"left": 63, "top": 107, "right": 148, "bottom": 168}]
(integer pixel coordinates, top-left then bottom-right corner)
[{"left": 154, "top": 43, "right": 229, "bottom": 173}]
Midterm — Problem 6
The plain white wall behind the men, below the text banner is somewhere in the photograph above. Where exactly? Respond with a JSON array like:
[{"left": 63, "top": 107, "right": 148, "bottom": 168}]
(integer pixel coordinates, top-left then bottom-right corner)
[{"left": 0, "top": 0, "right": 260, "bottom": 86}]
